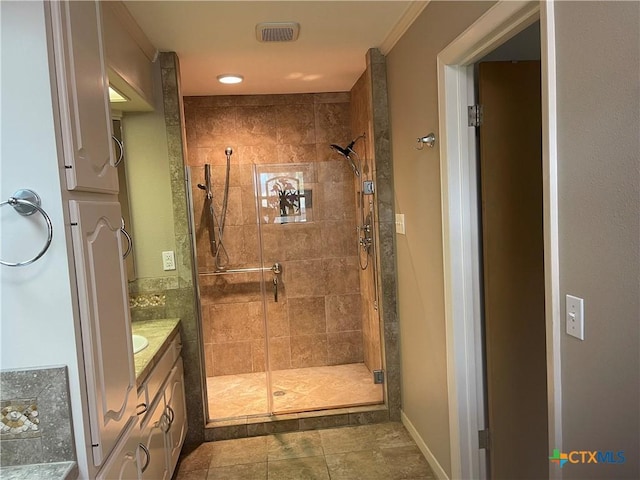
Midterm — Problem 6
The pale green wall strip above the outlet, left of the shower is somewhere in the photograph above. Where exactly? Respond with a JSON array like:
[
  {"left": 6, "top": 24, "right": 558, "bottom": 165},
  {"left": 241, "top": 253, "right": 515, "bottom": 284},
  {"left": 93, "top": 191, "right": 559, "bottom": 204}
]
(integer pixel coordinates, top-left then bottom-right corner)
[{"left": 122, "top": 62, "right": 178, "bottom": 278}]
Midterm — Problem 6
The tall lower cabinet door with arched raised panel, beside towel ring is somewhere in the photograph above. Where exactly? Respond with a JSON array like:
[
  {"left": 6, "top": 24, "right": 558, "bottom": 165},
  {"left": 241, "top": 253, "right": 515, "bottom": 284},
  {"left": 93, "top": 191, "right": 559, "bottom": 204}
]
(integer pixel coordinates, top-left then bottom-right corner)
[{"left": 69, "top": 200, "right": 136, "bottom": 465}]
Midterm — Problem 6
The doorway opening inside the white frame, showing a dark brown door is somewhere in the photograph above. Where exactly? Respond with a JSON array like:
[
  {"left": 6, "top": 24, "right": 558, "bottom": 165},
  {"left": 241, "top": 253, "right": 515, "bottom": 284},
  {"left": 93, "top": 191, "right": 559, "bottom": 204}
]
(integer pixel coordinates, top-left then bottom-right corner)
[{"left": 474, "top": 22, "right": 549, "bottom": 479}]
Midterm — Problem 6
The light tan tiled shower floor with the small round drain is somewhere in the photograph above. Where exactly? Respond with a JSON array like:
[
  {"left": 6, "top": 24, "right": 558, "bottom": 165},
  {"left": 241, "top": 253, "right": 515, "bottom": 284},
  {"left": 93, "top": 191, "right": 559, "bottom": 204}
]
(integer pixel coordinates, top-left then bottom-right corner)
[{"left": 207, "top": 363, "right": 382, "bottom": 419}]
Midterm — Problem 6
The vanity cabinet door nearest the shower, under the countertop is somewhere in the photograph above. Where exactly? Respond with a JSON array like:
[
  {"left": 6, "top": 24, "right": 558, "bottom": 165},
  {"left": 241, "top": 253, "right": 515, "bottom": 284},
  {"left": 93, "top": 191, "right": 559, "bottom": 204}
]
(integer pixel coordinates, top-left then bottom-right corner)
[{"left": 164, "top": 358, "right": 187, "bottom": 474}]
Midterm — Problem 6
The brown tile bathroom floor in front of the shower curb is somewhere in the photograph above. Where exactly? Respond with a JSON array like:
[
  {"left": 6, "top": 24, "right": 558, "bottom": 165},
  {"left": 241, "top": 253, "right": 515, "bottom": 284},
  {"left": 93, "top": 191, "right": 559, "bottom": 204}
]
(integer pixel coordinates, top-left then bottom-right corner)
[{"left": 173, "top": 422, "right": 436, "bottom": 480}]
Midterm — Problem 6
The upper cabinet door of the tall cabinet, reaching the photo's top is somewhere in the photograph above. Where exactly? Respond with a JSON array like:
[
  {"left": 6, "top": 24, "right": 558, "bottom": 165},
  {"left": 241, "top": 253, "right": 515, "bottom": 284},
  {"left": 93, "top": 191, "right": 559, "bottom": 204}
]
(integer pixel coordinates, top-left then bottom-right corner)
[{"left": 50, "top": 1, "right": 118, "bottom": 193}]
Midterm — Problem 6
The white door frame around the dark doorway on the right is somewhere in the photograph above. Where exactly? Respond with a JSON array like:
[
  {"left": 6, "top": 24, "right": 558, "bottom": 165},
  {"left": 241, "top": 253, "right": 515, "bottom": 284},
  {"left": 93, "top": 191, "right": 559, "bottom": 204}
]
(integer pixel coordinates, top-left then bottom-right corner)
[{"left": 438, "top": 1, "right": 562, "bottom": 478}]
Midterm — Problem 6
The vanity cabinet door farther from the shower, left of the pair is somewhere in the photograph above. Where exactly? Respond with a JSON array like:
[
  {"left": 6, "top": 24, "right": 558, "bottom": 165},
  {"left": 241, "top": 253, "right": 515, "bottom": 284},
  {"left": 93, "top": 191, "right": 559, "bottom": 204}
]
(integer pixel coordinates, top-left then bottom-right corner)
[{"left": 140, "top": 395, "right": 170, "bottom": 480}]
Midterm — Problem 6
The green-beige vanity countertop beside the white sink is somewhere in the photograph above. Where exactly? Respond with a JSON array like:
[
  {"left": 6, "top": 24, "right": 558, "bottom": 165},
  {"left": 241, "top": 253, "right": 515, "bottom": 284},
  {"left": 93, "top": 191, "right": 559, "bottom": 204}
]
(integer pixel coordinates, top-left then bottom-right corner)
[{"left": 131, "top": 318, "right": 180, "bottom": 388}]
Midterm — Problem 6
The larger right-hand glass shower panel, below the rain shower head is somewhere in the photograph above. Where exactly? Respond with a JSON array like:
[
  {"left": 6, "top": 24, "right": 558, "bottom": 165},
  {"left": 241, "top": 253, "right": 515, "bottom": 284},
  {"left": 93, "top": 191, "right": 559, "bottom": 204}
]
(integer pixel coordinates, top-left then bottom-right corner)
[{"left": 254, "top": 162, "right": 382, "bottom": 413}]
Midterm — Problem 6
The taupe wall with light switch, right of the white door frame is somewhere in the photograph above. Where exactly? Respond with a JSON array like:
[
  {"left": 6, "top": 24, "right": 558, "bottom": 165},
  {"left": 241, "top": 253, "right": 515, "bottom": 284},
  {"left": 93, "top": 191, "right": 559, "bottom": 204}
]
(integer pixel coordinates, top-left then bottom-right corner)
[{"left": 556, "top": 2, "right": 640, "bottom": 479}]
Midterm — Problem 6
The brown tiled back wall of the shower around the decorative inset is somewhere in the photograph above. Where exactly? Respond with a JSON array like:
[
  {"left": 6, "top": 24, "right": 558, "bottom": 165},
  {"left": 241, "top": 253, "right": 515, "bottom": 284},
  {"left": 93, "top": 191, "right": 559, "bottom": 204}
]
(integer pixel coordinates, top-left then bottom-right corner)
[{"left": 184, "top": 93, "right": 364, "bottom": 376}]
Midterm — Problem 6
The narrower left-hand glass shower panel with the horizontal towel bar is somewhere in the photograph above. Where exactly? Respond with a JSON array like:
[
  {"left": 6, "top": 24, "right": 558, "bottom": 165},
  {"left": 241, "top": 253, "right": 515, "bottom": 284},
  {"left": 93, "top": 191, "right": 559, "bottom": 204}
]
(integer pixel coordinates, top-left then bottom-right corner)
[{"left": 187, "top": 164, "right": 272, "bottom": 420}]
